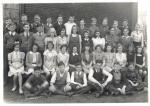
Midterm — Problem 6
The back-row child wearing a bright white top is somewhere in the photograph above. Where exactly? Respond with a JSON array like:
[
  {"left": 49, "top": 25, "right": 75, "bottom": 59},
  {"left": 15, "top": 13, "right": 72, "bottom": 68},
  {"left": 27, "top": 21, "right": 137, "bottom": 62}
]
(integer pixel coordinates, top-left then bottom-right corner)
[{"left": 64, "top": 16, "right": 76, "bottom": 39}]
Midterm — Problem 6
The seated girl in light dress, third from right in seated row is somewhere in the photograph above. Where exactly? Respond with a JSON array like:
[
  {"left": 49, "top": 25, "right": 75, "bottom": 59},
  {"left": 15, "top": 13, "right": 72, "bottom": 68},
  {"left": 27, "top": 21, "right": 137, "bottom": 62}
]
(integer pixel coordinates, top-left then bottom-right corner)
[{"left": 104, "top": 45, "right": 115, "bottom": 72}]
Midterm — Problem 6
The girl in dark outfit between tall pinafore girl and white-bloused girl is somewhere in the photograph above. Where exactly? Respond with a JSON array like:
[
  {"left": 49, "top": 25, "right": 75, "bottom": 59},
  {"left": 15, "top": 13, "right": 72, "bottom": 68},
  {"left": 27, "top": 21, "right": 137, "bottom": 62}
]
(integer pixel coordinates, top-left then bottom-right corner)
[{"left": 82, "top": 31, "right": 93, "bottom": 51}]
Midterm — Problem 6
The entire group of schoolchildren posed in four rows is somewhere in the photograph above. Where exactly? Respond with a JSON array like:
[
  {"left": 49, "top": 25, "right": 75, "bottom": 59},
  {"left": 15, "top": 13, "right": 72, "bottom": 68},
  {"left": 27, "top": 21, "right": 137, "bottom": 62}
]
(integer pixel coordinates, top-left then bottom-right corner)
[{"left": 3, "top": 14, "right": 148, "bottom": 97}]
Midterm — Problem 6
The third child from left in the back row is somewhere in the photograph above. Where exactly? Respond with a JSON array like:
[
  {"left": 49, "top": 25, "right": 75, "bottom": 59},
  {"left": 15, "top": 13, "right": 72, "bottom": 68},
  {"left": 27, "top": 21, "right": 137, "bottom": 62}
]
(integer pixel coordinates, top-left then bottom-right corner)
[{"left": 31, "top": 14, "right": 44, "bottom": 33}]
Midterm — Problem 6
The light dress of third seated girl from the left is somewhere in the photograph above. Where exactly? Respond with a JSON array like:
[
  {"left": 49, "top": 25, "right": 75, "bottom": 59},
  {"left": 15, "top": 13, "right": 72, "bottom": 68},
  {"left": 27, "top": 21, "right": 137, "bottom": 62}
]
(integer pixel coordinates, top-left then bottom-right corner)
[{"left": 43, "top": 50, "right": 57, "bottom": 73}]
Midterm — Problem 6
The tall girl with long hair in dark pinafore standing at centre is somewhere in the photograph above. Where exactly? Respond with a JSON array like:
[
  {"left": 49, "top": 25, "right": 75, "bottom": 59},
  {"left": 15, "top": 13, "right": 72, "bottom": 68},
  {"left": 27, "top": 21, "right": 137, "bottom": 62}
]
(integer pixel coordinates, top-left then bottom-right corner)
[{"left": 68, "top": 25, "right": 82, "bottom": 53}]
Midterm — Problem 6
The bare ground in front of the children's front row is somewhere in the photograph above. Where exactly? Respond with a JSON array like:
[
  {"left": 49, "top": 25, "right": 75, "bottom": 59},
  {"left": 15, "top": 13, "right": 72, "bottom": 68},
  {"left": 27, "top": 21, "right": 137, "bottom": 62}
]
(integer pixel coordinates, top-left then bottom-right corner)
[{"left": 4, "top": 84, "right": 148, "bottom": 103}]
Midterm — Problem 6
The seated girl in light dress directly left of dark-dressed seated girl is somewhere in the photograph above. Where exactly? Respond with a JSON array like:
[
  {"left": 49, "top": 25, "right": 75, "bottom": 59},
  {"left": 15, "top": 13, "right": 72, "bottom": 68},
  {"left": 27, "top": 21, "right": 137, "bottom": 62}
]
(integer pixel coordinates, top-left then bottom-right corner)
[{"left": 57, "top": 45, "right": 69, "bottom": 71}]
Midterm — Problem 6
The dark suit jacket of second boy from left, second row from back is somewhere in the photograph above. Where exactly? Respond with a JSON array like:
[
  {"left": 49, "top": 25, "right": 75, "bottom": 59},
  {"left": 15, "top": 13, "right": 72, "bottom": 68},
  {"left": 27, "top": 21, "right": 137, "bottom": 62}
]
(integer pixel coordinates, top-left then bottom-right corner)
[{"left": 19, "top": 32, "right": 33, "bottom": 53}]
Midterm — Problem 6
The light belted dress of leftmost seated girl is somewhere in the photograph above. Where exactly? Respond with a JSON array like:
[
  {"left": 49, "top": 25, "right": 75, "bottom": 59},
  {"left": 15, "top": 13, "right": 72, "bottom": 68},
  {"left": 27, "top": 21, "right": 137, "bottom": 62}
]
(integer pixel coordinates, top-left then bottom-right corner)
[{"left": 8, "top": 51, "right": 25, "bottom": 77}]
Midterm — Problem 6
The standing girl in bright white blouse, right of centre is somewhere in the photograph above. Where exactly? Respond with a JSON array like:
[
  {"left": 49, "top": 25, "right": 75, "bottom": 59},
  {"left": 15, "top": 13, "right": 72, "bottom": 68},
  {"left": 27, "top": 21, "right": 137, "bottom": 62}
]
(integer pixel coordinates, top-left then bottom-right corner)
[{"left": 92, "top": 31, "right": 105, "bottom": 49}]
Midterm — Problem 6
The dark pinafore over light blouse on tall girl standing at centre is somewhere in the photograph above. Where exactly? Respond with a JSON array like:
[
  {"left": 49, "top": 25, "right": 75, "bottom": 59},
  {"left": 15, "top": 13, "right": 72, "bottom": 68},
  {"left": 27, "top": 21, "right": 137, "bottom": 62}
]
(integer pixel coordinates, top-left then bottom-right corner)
[{"left": 68, "top": 34, "right": 81, "bottom": 53}]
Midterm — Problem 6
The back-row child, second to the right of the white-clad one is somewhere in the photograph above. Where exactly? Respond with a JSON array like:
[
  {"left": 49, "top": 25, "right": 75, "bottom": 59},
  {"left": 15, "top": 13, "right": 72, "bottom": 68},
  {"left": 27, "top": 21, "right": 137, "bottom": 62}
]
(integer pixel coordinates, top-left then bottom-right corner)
[{"left": 89, "top": 17, "right": 99, "bottom": 38}]
